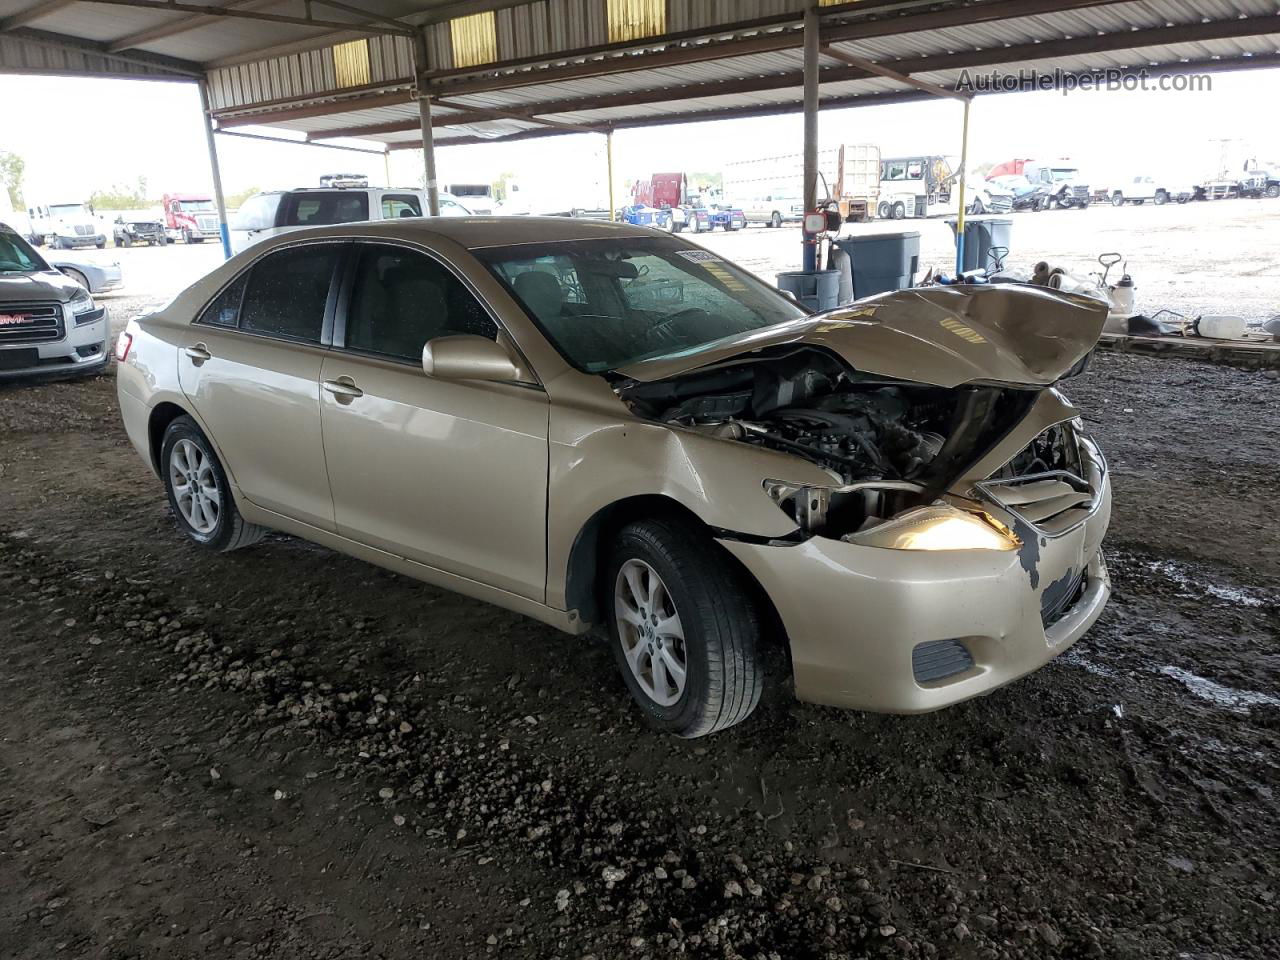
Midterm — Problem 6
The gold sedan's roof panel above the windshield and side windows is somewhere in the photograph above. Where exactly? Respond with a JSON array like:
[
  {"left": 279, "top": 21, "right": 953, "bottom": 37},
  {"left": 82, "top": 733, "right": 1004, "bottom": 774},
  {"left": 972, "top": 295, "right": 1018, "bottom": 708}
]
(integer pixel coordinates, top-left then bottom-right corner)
[{"left": 259, "top": 216, "right": 664, "bottom": 250}]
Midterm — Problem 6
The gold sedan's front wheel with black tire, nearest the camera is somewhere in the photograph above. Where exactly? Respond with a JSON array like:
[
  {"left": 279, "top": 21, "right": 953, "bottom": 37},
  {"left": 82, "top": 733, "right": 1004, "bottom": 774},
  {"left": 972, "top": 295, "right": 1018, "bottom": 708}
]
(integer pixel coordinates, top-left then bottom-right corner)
[{"left": 603, "top": 518, "right": 764, "bottom": 739}]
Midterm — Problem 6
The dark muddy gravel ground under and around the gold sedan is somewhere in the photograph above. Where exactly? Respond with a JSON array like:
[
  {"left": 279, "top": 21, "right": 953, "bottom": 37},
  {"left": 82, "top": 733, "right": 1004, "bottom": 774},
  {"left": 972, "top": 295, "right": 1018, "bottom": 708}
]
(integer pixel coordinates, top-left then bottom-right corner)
[{"left": 0, "top": 356, "right": 1280, "bottom": 960}]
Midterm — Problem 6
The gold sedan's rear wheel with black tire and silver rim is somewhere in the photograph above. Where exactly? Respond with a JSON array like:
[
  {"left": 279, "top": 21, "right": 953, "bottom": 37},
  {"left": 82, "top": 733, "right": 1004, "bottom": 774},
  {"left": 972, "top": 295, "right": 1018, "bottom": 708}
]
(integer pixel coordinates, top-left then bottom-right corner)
[{"left": 160, "top": 416, "right": 266, "bottom": 552}]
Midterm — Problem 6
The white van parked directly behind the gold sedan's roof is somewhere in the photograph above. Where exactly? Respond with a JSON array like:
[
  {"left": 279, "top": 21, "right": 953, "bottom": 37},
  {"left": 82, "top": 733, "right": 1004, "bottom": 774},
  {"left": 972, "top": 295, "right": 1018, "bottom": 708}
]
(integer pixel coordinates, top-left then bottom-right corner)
[{"left": 228, "top": 186, "right": 471, "bottom": 253}]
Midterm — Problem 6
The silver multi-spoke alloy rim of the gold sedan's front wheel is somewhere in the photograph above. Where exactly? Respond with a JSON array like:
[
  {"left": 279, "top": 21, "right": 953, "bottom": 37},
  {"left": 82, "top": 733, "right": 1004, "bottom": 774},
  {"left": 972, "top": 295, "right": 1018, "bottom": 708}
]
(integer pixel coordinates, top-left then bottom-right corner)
[{"left": 613, "top": 559, "right": 689, "bottom": 707}]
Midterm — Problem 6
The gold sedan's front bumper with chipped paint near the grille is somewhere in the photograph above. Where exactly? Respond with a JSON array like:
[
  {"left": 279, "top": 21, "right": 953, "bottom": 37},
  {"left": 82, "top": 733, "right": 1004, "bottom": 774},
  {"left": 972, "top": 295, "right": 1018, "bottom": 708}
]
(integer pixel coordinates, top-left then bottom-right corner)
[{"left": 719, "top": 476, "right": 1111, "bottom": 713}]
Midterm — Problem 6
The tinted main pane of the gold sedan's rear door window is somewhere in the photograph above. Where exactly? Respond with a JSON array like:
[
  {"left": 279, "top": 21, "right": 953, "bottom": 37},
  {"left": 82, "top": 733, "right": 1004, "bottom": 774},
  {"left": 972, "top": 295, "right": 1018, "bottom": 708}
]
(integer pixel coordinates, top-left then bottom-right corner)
[{"left": 239, "top": 243, "right": 340, "bottom": 343}]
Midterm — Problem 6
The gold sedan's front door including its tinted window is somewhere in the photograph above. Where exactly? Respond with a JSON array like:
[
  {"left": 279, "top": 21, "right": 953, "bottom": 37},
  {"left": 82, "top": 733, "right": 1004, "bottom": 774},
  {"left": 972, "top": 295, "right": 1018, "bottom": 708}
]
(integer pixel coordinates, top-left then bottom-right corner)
[{"left": 320, "top": 243, "right": 548, "bottom": 602}]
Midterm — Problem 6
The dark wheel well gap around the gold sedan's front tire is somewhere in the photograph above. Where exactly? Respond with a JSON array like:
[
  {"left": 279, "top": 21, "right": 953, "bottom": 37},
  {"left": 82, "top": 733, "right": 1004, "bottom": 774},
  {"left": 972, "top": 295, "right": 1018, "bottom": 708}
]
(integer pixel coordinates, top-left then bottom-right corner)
[{"left": 564, "top": 494, "right": 790, "bottom": 649}]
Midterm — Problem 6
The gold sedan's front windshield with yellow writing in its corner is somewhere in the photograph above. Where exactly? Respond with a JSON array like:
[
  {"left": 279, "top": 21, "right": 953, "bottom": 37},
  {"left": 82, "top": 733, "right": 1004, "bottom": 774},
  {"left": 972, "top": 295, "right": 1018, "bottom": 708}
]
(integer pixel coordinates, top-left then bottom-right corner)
[{"left": 472, "top": 237, "right": 808, "bottom": 374}]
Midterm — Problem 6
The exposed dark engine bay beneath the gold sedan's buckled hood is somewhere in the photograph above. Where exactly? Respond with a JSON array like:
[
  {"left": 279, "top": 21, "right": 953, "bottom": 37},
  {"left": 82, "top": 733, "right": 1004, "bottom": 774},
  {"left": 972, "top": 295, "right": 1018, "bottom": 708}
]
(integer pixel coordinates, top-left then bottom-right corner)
[{"left": 618, "top": 347, "right": 1038, "bottom": 535}]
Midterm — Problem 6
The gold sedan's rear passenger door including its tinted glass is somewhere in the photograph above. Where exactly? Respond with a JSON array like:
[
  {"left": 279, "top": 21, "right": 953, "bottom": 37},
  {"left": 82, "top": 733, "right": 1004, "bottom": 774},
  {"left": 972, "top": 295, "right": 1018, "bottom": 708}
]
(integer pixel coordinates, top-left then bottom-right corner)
[{"left": 178, "top": 242, "right": 347, "bottom": 530}]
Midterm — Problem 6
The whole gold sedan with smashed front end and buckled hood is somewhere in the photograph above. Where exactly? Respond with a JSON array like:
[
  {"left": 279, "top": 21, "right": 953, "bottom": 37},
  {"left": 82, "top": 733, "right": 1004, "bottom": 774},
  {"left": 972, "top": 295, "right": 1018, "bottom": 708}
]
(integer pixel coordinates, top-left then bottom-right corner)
[{"left": 116, "top": 219, "right": 1110, "bottom": 737}]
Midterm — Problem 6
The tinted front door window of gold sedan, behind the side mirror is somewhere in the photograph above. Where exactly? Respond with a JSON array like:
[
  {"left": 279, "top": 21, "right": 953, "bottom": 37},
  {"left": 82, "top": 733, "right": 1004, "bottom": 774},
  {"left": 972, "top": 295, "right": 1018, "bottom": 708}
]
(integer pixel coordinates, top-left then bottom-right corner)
[{"left": 346, "top": 243, "right": 498, "bottom": 362}]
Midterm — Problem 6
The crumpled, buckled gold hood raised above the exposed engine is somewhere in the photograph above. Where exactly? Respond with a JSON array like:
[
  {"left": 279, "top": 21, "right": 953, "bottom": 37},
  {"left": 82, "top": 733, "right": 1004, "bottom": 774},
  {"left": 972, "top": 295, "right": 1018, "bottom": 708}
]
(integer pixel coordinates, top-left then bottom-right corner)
[{"left": 617, "top": 284, "right": 1107, "bottom": 387}]
